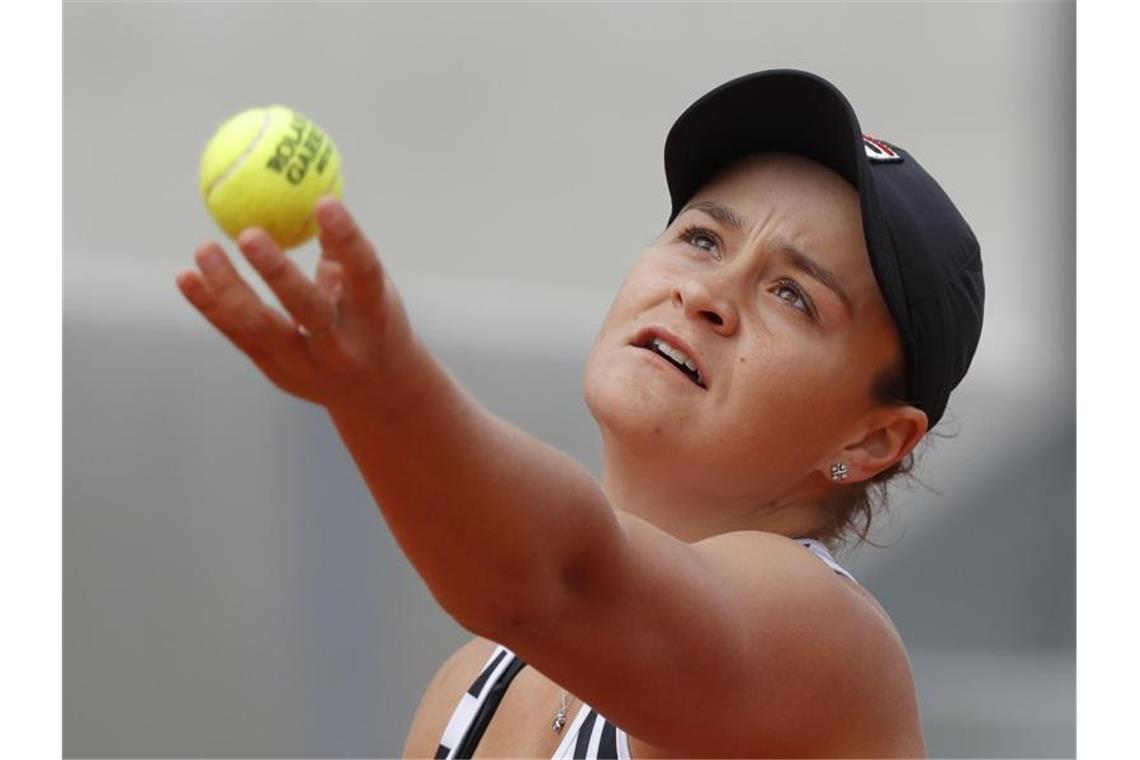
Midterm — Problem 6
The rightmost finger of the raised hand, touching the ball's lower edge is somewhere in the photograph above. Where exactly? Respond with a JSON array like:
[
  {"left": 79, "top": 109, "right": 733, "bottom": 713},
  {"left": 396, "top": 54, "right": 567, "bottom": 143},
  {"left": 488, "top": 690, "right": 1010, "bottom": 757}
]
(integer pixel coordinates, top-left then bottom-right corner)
[{"left": 316, "top": 196, "right": 384, "bottom": 311}]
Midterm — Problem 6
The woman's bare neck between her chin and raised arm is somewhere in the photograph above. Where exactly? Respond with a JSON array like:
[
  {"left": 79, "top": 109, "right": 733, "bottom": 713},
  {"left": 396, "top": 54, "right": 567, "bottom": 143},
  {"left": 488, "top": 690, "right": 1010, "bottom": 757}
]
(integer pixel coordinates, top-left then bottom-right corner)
[{"left": 602, "top": 448, "right": 824, "bottom": 544}]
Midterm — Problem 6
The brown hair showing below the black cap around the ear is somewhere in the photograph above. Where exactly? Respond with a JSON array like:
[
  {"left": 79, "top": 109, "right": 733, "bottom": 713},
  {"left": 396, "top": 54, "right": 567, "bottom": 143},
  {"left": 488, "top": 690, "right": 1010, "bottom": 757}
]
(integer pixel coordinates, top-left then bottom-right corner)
[{"left": 817, "top": 362, "right": 921, "bottom": 562}]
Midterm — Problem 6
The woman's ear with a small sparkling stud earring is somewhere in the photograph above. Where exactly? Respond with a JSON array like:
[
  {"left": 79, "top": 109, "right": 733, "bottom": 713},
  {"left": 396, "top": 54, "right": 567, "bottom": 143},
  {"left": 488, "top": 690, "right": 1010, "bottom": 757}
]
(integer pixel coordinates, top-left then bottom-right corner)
[{"left": 821, "top": 406, "right": 927, "bottom": 483}]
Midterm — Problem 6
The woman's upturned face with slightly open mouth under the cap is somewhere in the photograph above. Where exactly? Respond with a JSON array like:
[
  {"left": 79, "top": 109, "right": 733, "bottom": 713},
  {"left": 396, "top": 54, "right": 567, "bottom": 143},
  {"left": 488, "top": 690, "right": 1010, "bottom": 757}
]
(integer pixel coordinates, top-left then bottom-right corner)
[{"left": 585, "top": 154, "right": 901, "bottom": 499}]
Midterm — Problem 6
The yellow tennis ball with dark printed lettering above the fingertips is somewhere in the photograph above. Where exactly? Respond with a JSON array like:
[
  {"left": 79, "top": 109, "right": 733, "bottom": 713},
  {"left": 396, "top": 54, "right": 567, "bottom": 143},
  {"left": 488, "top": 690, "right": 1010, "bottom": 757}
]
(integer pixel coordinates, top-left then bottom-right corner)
[{"left": 198, "top": 106, "right": 342, "bottom": 248}]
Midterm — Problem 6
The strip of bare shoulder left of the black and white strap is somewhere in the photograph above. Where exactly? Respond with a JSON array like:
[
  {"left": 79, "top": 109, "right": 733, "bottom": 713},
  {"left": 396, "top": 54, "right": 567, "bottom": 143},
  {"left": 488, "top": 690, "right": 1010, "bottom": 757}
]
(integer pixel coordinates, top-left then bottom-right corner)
[{"left": 404, "top": 636, "right": 496, "bottom": 758}]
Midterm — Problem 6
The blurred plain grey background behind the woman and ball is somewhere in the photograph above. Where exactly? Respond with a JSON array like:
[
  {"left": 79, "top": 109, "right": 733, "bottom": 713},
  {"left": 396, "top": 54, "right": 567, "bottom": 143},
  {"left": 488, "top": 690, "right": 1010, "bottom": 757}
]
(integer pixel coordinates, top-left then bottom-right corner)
[{"left": 63, "top": 2, "right": 1075, "bottom": 757}]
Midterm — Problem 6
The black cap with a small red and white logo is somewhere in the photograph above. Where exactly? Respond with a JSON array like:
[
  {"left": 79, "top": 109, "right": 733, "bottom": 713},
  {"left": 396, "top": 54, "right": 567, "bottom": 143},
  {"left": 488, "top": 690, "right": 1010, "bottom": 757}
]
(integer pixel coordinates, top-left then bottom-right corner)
[{"left": 665, "top": 70, "right": 985, "bottom": 428}]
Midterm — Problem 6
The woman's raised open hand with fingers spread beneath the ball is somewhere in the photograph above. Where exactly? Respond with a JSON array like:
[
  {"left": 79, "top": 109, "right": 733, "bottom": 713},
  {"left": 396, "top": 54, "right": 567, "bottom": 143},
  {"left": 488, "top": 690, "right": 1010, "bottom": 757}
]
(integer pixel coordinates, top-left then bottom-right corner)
[{"left": 176, "top": 196, "right": 414, "bottom": 408}]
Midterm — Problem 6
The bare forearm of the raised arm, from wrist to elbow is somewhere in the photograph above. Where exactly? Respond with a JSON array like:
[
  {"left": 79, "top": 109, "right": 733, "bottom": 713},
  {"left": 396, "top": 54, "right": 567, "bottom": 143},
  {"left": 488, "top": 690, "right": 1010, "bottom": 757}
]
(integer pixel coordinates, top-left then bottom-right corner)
[{"left": 329, "top": 343, "right": 621, "bottom": 636}]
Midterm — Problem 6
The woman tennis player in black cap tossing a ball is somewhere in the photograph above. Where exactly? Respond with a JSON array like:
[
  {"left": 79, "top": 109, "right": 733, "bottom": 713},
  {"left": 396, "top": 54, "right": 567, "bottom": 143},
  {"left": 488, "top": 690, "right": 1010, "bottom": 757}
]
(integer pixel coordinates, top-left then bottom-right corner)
[{"left": 178, "top": 70, "right": 984, "bottom": 758}]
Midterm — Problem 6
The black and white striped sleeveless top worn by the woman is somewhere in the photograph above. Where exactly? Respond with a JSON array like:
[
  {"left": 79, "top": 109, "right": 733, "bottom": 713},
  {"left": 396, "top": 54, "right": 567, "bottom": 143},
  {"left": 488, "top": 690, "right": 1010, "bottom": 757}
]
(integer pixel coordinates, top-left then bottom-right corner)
[{"left": 435, "top": 538, "right": 855, "bottom": 760}]
